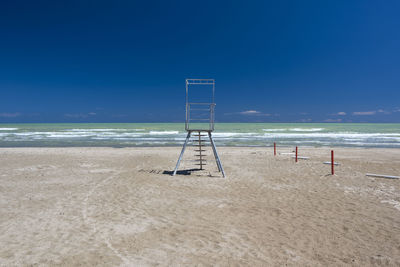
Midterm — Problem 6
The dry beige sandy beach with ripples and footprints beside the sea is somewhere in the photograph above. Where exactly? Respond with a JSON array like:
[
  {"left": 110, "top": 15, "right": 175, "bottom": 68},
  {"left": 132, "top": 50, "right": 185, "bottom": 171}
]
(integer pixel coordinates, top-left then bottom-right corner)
[{"left": 0, "top": 147, "right": 400, "bottom": 266}]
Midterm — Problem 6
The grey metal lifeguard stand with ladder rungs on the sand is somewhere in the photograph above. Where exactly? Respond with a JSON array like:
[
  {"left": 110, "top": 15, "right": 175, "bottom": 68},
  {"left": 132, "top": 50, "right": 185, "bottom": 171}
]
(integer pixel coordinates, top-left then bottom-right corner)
[{"left": 172, "top": 79, "right": 225, "bottom": 177}]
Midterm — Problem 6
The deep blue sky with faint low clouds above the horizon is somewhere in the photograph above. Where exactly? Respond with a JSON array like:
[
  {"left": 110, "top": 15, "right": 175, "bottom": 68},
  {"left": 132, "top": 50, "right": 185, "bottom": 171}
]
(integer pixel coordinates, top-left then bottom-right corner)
[{"left": 0, "top": 0, "right": 400, "bottom": 122}]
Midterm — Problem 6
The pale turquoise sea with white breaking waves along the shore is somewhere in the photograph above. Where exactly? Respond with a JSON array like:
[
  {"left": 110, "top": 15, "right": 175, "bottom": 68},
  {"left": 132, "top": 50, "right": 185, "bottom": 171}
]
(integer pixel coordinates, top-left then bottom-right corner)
[{"left": 0, "top": 123, "right": 400, "bottom": 148}]
